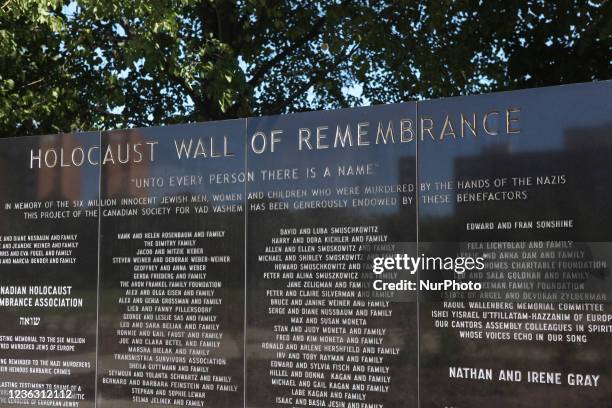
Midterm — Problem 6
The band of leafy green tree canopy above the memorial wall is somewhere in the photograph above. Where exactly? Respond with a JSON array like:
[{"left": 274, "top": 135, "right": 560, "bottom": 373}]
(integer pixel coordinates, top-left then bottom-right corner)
[{"left": 0, "top": 0, "right": 612, "bottom": 135}]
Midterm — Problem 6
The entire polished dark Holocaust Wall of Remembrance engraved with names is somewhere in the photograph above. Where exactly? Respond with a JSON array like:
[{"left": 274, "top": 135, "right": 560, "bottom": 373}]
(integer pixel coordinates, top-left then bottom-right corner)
[{"left": 0, "top": 82, "right": 612, "bottom": 408}]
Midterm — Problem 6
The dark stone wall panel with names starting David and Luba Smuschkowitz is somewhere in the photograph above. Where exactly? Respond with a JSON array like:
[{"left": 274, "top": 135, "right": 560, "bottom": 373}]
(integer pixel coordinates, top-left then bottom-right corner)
[{"left": 246, "top": 104, "right": 417, "bottom": 408}]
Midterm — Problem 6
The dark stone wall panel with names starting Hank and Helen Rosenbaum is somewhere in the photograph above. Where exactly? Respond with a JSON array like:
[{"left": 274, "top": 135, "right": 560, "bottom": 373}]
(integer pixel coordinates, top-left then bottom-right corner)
[{"left": 98, "top": 120, "right": 245, "bottom": 408}]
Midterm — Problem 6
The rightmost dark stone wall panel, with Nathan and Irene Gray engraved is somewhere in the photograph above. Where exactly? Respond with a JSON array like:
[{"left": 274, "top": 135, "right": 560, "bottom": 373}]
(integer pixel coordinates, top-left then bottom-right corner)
[{"left": 418, "top": 82, "right": 612, "bottom": 408}]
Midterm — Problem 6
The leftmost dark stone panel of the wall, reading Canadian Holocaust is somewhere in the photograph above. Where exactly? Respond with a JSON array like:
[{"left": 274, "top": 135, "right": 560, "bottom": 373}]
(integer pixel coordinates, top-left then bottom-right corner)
[{"left": 0, "top": 132, "right": 99, "bottom": 407}]
